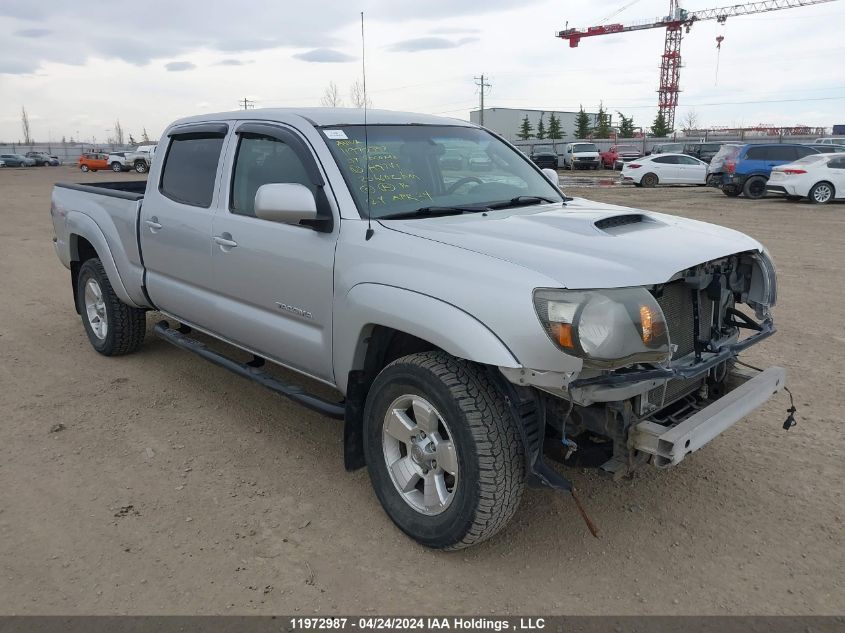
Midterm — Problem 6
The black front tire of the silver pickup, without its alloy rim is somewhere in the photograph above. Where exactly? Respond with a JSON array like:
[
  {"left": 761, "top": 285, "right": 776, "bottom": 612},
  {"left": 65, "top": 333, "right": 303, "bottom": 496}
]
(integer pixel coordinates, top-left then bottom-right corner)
[{"left": 364, "top": 351, "right": 525, "bottom": 550}]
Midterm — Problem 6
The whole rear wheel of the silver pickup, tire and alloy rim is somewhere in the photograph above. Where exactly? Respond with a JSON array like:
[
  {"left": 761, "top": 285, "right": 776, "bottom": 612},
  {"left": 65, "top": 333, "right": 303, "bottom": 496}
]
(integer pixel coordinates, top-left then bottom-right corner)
[{"left": 76, "top": 258, "right": 147, "bottom": 356}]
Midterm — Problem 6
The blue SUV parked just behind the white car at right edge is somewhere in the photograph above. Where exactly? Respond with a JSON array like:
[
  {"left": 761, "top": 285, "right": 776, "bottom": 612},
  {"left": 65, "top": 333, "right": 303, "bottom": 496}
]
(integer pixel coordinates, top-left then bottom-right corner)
[{"left": 709, "top": 143, "right": 819, "bottom": 200}]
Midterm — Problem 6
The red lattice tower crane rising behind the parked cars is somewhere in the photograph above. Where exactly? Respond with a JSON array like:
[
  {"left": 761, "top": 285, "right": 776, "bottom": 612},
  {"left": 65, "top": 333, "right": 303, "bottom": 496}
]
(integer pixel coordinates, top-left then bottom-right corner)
[{"left": 557, "top": 0, "right": 834, "bottom": 130}]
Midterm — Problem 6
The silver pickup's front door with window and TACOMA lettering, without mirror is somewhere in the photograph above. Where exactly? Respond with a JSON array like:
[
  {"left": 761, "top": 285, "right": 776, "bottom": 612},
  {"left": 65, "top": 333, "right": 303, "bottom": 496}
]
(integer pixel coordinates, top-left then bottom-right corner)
[{"left": 211, "top": 122, "right": 338, "bottom": 384}]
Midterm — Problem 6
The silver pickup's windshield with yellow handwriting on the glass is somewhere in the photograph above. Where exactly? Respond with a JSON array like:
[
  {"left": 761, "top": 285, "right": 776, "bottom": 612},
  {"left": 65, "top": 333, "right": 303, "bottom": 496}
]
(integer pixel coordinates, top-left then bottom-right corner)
[{"left": 322, "top": 125, "right": 563, "bottom": 219}]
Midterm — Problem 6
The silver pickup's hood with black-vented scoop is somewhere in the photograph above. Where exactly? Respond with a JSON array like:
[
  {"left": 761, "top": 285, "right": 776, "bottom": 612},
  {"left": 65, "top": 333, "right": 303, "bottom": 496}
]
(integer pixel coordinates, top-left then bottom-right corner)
[{"left": 382, "top": 199, "right": 762, "bottom": 289}]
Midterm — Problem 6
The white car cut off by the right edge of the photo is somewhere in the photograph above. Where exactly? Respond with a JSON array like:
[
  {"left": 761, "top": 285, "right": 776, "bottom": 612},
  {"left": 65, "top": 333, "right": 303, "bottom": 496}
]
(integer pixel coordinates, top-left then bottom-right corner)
[{"left": 766, "top": 152, "right": 845, "bottom": 204}]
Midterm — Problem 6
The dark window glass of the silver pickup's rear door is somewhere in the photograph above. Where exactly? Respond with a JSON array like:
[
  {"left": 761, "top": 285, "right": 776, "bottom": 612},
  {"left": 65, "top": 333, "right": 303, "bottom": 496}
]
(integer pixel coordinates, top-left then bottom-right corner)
[{"left": 159, "top": 132, "right": 226, "bottom": 208}]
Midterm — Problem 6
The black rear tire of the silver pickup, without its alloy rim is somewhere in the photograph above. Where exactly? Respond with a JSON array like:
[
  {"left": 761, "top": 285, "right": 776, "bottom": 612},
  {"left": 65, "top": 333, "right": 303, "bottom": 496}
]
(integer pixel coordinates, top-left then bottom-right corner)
[{"left": 76, "top": 257, "right": 147, "bottom": 356}]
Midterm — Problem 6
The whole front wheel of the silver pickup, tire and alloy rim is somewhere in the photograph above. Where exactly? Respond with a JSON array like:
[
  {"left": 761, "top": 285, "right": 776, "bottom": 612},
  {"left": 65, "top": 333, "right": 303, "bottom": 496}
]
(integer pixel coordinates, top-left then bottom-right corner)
[{"left": 364, "top": 352, "right": 525, "bottom": 549}]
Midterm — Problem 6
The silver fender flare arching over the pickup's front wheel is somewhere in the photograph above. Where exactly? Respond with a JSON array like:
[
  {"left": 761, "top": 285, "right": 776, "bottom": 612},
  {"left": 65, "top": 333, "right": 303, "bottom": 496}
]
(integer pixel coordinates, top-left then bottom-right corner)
[{"left": 333, "top": 283, "right": 521, "bottom": 392}]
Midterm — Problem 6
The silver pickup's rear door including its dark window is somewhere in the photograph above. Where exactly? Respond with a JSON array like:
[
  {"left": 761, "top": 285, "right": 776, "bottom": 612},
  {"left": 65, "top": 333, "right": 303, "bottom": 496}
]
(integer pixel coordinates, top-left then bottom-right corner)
[{"left": 139, "top": 123, "right": 229, "bottom": 330}]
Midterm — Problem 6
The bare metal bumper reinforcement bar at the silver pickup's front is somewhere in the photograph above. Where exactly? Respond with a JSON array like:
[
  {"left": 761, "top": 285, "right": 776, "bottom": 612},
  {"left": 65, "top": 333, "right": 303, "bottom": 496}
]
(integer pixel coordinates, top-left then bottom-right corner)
[{"left": 630, "top": 367, "right": 786, "bottom": 468}]
